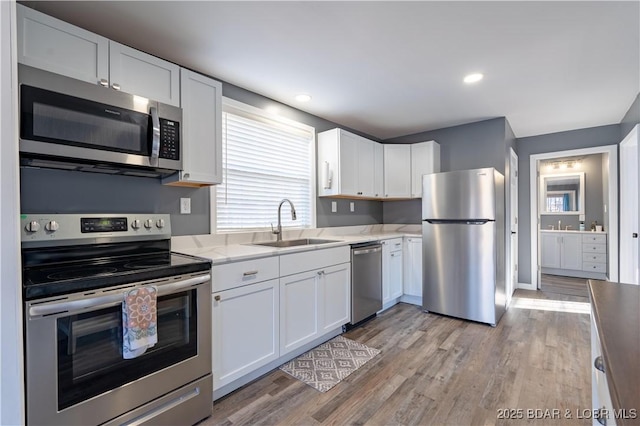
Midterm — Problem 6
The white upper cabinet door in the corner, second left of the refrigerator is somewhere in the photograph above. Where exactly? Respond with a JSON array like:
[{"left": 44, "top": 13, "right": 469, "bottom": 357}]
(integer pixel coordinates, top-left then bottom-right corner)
[{"left": 384, "top": 144, "right": 411, "bottom": 198}]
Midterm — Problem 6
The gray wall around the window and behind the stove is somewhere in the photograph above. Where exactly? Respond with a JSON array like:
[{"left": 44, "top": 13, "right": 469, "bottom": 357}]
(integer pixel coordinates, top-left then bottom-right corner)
[{"left": 20, "top": 79, "right": 382, "bottom": 235}]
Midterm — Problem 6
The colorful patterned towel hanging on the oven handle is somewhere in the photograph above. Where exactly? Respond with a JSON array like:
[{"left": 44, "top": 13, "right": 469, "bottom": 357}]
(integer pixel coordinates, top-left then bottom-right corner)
[{"left": 122, "top": 286, "right": 158, "bottom": 359}]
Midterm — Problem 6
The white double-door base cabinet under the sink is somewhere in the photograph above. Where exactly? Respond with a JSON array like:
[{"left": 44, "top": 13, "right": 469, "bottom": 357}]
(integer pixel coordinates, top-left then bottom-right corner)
[{"left": 280, "top": 246, "right": 351, "bottom": 355}]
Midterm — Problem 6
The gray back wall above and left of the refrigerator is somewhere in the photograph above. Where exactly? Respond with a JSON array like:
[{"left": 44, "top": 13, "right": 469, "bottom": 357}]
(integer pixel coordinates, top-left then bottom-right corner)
[{"left": 382, "top": 117, "right": 515, "bottom": 224}]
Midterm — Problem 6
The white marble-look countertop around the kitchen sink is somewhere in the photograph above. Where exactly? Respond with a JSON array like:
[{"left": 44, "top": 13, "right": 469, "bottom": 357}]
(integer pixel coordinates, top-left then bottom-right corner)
[{"left": 171, "top": 225, "right": 422, "bottom": 265}]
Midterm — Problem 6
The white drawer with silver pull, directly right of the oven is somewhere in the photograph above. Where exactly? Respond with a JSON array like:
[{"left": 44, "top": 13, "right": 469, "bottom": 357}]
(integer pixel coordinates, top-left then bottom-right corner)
[{"left": 211, "top": 257, "right": 279, "bottom": 292}]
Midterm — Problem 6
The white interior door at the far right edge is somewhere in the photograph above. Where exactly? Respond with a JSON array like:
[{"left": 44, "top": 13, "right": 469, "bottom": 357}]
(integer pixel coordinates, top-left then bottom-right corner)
[{"left": 620, "top": 126, "right": 640, "bottom": 284}]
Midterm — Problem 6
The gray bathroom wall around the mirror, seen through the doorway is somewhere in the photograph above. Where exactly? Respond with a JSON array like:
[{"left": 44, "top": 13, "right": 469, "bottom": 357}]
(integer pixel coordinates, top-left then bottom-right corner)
[{"left": 540, "top": 154, "right": 606, "bottom": 230}]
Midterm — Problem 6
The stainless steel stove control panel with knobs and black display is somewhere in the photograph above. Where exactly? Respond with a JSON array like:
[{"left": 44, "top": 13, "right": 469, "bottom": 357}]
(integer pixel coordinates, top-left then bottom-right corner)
[{"left": 20, "top": 213, "right": 171, "bottom": 246}]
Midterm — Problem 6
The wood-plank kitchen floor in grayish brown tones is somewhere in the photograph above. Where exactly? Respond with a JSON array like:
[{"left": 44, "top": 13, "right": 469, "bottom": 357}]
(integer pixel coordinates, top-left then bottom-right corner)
[{"left": 200, "top": 290, "right": 591, "bottom": 426}]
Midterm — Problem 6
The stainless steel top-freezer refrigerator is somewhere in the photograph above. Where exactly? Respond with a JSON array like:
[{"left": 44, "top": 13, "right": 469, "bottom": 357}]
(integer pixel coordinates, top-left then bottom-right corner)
[{"left": 422, "top": 168, "right": 506, "bottom": 326}]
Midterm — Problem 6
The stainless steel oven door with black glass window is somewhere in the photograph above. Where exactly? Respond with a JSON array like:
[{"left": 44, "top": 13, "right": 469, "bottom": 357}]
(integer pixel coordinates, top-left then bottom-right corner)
[{"left": 25, "top": 274, "right": 212, "bottom": 425}]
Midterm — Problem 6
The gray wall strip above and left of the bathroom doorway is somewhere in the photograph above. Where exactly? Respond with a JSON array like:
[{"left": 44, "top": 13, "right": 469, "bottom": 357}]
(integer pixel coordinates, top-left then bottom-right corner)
[{"left": 516, "top": 124, "right": 621, "bottom": 283}]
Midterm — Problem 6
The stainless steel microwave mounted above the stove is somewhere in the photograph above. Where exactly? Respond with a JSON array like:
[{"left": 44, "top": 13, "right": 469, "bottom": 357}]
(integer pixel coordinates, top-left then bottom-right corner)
[{"left": 18, "top": 64, "right": 182, "bottom": 176}]
